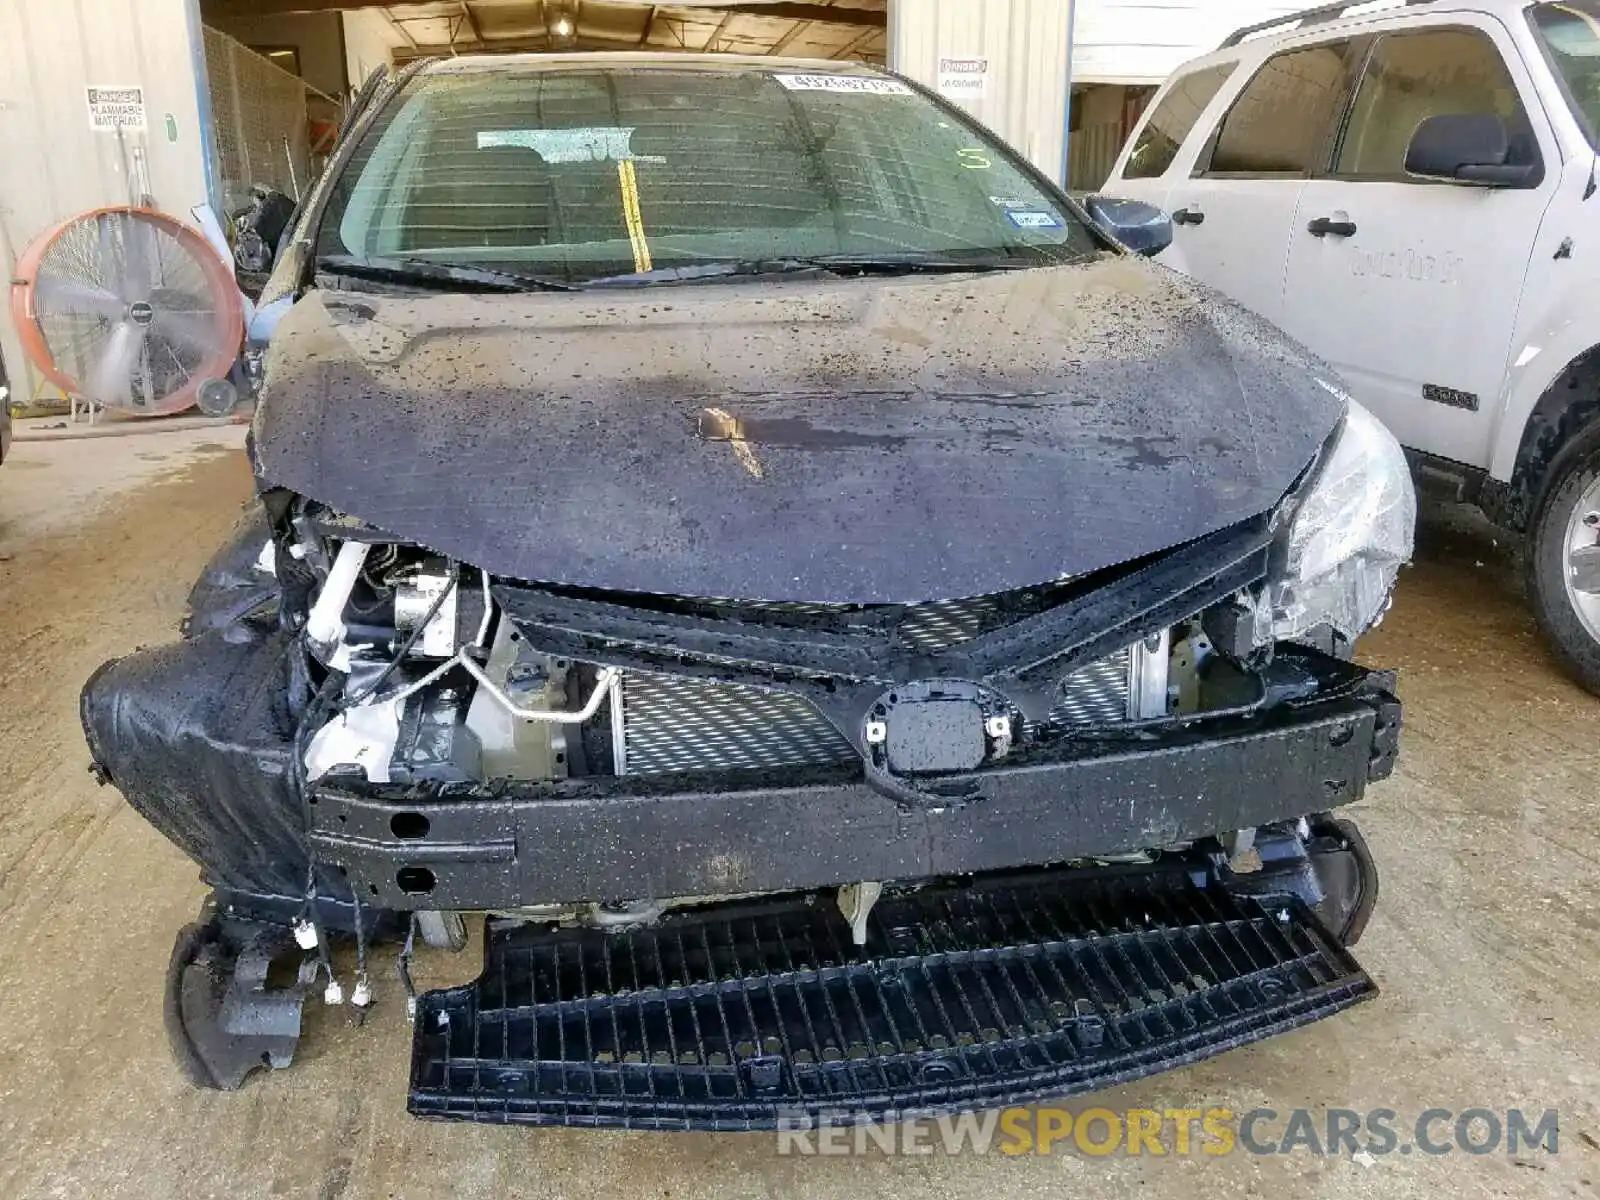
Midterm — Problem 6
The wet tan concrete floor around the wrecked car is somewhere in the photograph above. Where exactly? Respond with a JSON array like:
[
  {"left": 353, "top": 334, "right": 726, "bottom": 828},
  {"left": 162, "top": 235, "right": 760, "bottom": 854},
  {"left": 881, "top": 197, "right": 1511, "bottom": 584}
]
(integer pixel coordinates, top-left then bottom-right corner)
[{"left": 0, "top": 429, "right": 1600, "bottom": 1200}]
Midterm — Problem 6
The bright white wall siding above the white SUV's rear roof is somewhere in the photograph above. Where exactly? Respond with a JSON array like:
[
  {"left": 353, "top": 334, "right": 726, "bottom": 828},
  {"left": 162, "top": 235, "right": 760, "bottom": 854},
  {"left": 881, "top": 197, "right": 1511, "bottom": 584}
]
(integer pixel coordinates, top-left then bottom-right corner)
[{"left": 1068, "top": 0, "right": 1315, "bottom": 83}]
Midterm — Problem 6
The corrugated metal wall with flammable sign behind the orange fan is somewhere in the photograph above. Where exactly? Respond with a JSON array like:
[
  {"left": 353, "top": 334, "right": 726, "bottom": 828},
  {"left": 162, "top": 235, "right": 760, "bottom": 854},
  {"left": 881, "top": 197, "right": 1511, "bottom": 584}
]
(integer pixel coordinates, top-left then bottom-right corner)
[{"left": 0, "top": 0, "right": 206, "bottom": 392}]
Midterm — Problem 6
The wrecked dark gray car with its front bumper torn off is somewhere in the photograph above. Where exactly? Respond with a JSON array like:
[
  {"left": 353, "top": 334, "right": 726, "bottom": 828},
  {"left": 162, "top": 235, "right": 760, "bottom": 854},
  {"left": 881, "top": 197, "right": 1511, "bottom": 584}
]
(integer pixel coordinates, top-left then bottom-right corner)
[{"left": 83, "top": 56, "right": 1414, "bottom": 1128}]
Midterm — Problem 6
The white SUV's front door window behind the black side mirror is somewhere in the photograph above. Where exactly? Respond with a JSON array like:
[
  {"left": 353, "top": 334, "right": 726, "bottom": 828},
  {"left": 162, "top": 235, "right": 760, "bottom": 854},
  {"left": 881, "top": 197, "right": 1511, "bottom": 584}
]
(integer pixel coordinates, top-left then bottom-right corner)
[{"left": 1334, "top": 29, "right": 1538, "bottom": 179}]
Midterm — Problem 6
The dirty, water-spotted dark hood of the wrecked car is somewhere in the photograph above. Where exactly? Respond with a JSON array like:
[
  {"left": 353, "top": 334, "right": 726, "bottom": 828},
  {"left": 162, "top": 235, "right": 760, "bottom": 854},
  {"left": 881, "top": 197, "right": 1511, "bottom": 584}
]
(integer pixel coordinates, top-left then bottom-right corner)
[{"left": 251, "top": 256, "right": 1344, "bottom": 603}]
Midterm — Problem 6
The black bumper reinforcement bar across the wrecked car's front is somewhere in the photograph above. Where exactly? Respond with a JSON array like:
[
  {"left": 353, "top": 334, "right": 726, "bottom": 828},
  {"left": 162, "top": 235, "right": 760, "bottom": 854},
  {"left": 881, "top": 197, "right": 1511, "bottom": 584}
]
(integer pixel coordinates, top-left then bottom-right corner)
[{"left": 307, "top": 669, "right": 1400, "bottom": 910}]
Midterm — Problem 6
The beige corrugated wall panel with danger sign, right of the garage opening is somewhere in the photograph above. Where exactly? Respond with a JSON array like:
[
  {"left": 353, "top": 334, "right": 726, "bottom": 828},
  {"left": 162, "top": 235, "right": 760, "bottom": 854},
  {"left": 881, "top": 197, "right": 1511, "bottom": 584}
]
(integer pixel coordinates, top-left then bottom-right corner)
[{"left": 890, "top": 0, "right": 1072, "bottom": 179}]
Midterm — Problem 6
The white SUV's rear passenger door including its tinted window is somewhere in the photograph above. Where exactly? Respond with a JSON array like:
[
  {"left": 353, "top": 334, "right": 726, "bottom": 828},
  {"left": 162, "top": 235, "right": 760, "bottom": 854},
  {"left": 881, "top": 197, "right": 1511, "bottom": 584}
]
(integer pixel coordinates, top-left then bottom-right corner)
[{"left": 1162, "top": 38, "right": 1354, "bottom": 320}]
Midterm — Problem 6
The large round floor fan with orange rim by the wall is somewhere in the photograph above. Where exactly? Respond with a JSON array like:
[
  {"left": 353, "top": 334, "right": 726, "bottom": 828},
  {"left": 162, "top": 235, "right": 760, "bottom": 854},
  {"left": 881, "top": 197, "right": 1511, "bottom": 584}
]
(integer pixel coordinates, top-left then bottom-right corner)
[{"left": 11, "top": 208, "right": 243, "bottom": 416}]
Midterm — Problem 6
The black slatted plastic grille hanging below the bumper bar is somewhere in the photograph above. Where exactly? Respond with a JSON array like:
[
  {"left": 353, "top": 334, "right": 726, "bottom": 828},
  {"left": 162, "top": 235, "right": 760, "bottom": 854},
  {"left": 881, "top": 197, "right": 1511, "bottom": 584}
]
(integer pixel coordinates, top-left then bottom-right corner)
[{"left": 410, "top": 867, "right": 1376, "bottom": 1130}]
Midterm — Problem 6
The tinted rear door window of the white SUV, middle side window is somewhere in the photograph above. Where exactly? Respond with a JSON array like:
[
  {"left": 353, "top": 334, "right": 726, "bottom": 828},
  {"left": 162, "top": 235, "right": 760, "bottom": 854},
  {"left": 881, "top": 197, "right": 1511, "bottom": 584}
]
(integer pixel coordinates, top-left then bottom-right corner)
[{"left": 1208, "top": 40, "right": 1350, "bottom": 174}]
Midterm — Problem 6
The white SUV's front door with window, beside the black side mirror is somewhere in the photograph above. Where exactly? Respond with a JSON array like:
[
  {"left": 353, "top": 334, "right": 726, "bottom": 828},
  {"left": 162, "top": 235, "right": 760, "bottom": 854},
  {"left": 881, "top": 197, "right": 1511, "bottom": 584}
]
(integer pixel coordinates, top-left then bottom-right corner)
[{"left": 1282, "top": 22, "right": 1560, "bottom": 467}]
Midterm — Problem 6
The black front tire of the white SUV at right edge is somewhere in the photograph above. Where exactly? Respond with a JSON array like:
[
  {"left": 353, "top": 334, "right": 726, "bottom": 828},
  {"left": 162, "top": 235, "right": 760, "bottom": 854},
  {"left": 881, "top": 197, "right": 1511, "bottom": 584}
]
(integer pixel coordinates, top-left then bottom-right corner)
[{"left": 1526, "top": 427, "right": 1600, "bottom": 696}]
